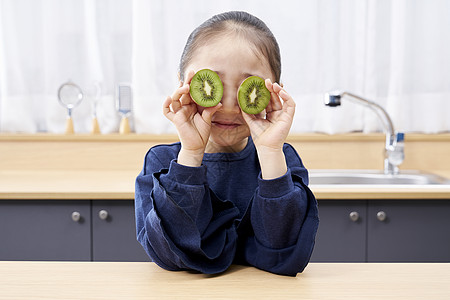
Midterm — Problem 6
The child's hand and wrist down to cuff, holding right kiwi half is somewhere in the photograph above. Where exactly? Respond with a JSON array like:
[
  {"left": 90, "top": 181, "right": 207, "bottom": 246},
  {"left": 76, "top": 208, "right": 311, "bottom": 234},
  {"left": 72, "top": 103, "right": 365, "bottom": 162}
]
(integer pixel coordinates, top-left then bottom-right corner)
[{"left": 242, "top": 79, "right": 295, "bottom": 179}]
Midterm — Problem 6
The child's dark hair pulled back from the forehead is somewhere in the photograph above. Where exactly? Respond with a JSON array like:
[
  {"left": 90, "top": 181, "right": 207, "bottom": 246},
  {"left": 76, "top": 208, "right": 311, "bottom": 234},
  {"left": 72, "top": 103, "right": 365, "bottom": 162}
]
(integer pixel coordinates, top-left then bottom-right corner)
[{"left": 179, "top": 11, "right": 281, "bottom": 82}]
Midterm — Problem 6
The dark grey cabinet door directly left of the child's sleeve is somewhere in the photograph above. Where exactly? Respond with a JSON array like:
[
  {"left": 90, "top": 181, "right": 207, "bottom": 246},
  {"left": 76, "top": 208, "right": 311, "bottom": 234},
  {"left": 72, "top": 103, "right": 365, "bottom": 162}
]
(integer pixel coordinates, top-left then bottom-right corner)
[{"left": 92, "top": 200, "right": 150, "bottom": 261}]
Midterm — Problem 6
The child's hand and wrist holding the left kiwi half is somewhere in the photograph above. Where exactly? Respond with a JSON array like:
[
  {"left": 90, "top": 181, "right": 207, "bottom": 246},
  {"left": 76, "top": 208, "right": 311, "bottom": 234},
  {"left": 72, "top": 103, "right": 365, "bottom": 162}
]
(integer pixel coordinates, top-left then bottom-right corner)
[{"left": 163, "top": 70, "right": 222, "bottom": 167}]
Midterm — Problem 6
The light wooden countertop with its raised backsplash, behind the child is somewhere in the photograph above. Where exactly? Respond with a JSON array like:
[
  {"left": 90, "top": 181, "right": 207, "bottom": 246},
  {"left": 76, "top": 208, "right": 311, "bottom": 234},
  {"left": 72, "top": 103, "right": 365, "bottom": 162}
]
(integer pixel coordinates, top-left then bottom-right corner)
[{"left": 0, "top": 133, "right": 450, "bottom": 200}]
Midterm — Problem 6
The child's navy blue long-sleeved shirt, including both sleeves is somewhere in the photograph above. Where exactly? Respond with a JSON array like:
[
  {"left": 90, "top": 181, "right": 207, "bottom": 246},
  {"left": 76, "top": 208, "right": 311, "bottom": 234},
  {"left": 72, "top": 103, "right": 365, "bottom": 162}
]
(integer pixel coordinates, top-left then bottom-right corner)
[{"left": 135, "top": 138, "right": 319, "bottom": 276}]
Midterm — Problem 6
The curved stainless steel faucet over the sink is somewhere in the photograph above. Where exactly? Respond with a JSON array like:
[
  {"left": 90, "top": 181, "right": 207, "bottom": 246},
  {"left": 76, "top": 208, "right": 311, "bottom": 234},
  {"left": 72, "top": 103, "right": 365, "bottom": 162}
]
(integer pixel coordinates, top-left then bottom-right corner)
[{"left": 324, "top": 91, "right": 405, "bottom": 175}]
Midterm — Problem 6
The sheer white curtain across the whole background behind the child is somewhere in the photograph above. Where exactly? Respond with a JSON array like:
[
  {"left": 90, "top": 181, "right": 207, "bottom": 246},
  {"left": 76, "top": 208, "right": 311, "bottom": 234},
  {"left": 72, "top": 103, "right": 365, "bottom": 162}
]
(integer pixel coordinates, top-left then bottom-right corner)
[{"left": 0, "top": 0, "right": 450, "bottom": 133}]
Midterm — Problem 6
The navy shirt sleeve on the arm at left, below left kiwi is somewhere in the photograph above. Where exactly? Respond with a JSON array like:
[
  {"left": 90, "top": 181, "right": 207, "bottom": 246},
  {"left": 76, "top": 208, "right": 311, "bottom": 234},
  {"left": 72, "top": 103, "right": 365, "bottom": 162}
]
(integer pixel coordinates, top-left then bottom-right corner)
[{"left": 135, "top": 146, "right": 239, "bottom": 273}]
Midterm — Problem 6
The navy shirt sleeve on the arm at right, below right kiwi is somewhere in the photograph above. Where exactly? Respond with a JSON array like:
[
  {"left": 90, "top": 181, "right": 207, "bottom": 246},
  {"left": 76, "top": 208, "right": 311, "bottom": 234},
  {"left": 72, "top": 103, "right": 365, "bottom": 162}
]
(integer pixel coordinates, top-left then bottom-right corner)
[{"left": 239, "top": 146, "right": 319, "bottom": 276}]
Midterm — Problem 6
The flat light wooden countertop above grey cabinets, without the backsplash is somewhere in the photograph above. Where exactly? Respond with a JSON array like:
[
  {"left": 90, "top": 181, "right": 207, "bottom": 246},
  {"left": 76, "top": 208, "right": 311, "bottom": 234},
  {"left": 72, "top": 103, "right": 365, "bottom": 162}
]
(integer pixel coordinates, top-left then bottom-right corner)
[{"left": 0, "top": 170, "right": 450, "bottom": 200}]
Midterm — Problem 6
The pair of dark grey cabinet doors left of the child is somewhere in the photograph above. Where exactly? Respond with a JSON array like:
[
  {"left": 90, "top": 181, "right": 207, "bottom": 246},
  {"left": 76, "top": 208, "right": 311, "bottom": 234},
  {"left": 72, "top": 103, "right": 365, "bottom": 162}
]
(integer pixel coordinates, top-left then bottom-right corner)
[{"left": 0, "top": 200, "right": 150, "bottom": 261}]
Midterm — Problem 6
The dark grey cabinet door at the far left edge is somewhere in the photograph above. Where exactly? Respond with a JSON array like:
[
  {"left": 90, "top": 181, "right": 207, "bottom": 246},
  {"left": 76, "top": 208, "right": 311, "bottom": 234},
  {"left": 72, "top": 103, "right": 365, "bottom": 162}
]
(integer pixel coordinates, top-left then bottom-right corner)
[{"left": 0, "top": 200, "right": 91, "bottom": 260}]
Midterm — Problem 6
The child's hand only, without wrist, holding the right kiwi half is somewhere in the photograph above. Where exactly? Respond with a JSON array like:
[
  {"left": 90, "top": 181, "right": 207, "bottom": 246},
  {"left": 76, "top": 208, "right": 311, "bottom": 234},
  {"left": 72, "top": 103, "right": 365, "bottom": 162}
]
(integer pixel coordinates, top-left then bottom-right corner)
[{"left": 242, "top": 79, "right": 295, "bottom": 151}]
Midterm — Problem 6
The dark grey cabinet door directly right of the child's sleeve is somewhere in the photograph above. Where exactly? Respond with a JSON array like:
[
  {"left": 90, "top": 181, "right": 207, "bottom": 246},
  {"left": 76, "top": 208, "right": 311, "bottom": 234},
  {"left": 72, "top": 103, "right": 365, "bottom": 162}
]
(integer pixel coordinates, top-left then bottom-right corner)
[{"left": 311, "top": 200, "right": 367, "bottom": 262}]
